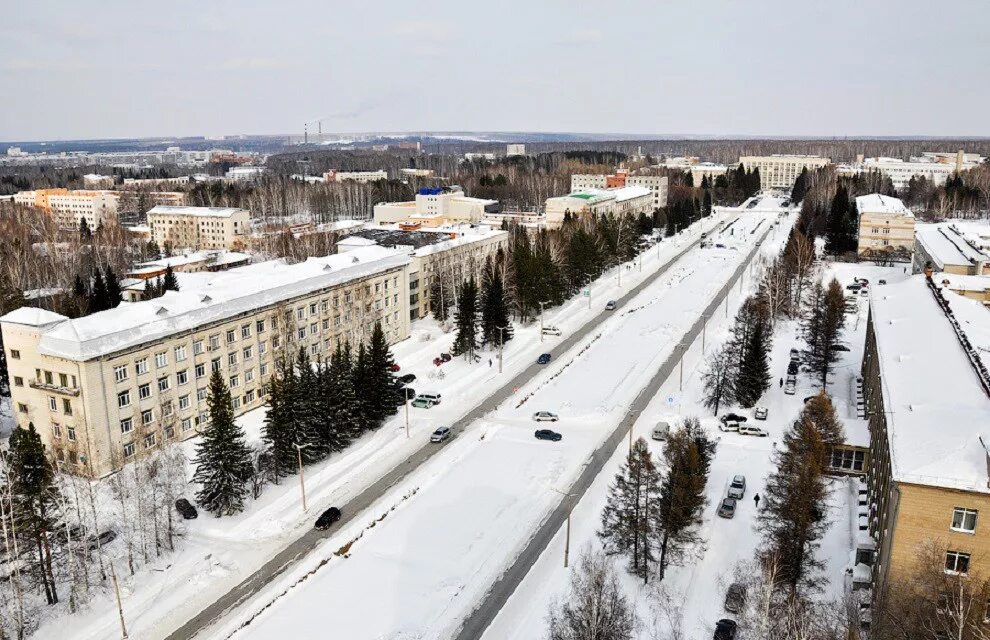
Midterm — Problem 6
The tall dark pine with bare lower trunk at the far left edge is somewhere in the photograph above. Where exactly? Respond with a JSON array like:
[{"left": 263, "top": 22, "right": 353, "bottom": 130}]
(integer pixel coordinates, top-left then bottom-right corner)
[{"left": 6, "top": 423, "right": 61, "bottom": 605}]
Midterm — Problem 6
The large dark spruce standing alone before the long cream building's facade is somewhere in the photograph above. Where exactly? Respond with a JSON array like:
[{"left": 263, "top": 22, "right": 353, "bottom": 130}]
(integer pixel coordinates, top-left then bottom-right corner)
[{"left": 193, "top": 371, "right": 254, "bottom": 518}]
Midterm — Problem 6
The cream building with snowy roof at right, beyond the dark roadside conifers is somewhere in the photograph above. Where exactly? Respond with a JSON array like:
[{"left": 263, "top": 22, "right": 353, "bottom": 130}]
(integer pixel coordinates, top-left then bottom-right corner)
[{"left": 856, "top": 193, "right": 914, "bottom": 261}]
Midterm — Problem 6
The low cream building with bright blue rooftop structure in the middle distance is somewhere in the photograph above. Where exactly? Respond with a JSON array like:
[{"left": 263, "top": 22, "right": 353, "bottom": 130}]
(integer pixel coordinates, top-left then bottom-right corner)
[{"left": 374, "top": 187, "right": 499, "bottom": 226}]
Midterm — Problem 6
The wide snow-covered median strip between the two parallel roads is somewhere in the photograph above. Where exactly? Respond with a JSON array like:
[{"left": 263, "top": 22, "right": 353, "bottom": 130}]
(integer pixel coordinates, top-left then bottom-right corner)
[{"left": 194, "top": 215, "right": 783, "bottom": 640}]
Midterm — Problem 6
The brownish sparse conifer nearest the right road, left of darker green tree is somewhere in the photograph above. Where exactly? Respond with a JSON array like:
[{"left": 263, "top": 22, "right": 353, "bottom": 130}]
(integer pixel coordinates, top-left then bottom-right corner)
[{"left": 598, "top": 438, "right": 660, "bottom": 579}]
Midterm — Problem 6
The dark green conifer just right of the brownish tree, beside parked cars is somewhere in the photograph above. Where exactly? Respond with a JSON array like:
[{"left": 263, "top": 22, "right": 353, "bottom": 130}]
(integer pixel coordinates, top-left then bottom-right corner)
[{"left": 655, "top": 418, "right": 715, "bottom": 580}]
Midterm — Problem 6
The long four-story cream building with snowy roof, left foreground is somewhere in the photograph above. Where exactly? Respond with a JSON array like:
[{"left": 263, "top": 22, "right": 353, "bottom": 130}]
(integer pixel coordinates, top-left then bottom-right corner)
[{"left": 0, "top": 246, "right": 410, "bottom": 477}]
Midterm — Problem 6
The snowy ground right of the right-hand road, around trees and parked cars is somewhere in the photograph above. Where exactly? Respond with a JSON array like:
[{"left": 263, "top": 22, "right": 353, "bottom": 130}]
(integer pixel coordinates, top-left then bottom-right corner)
[{"left": 484, "top": 254, "right": 909, "bottom": 640}]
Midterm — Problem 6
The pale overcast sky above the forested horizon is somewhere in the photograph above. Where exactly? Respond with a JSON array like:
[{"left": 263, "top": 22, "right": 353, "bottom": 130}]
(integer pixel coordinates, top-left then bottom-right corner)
[{"left": 0, "top": 0, "right": 990, "bottom": 140}]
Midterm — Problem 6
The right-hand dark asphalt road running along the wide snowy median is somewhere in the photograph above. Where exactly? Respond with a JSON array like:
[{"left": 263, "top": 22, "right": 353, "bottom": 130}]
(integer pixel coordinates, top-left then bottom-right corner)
[{"left": 456, "top": 222, "right": 772, "bottom": 640}]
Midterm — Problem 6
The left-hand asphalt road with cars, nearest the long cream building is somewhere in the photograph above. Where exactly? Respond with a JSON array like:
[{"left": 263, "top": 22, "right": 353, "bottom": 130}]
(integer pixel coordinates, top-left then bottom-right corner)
[{"left": 166, "top": 225, "right": 716, "bottom": 640}]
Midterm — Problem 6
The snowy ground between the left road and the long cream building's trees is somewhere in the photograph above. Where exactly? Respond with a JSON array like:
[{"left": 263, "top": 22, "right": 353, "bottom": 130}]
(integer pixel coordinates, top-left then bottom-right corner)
[{"left": 37, "top": 216, "right": 724, "bottom": 640}]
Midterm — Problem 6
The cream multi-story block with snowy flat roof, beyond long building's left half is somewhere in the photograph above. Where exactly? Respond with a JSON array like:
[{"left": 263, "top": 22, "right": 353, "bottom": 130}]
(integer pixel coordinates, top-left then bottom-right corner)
[{"left": 148, "top": 205, "right": 251, "bottom": 250}]
